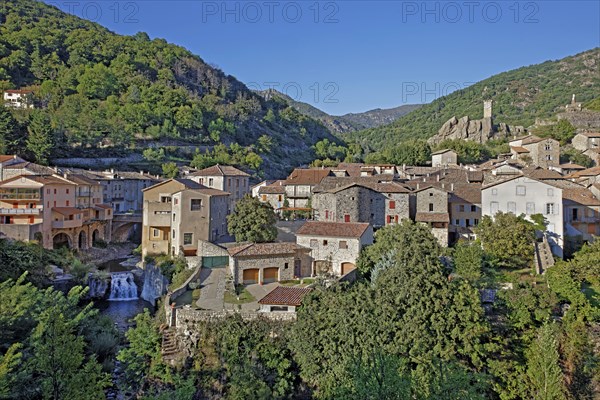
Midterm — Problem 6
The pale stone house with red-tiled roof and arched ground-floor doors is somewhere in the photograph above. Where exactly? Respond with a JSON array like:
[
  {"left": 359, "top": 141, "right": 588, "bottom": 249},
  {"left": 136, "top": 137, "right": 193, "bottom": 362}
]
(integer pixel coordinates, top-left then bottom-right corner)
[{"left": 296, "top": 221, "right": 373, "bottom": 277}]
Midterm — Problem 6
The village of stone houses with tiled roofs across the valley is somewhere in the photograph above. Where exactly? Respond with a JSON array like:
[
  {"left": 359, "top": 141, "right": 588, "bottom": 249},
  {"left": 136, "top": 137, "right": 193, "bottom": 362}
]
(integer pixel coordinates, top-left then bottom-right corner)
[{"left": 0, "top": 97, "right": 600, "bottom": 325}]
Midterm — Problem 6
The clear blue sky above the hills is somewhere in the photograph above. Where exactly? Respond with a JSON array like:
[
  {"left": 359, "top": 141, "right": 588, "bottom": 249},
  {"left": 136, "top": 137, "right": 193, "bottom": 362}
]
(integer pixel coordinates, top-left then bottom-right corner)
[{"left": 46, "top": 0, "right": 600, "bottom": 114}]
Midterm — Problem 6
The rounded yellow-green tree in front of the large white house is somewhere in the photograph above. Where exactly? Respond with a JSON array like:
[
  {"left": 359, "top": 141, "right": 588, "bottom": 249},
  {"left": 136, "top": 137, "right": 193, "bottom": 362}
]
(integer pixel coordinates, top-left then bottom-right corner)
[{"left": 475, "top": 212, "right": 535, "bottom": 268}]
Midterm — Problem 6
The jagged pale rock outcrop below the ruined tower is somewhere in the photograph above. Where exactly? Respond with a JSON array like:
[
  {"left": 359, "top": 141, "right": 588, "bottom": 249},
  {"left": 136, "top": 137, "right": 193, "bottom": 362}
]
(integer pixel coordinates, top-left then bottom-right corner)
[{"left": 427, "top": 116, "right": 525, "bottom": 145}]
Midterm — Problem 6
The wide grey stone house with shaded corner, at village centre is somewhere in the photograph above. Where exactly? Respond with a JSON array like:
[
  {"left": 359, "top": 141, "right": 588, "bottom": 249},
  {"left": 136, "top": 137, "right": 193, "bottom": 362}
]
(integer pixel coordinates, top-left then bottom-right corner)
[{"left": 313, "top": 178, "right": 410, "bottom": 228}]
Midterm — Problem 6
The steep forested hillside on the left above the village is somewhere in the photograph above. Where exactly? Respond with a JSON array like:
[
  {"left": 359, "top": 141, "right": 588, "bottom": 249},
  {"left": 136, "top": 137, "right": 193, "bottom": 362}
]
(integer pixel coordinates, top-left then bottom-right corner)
[{"left": 0, "top": 0, "right": 338, "bottom": 177}]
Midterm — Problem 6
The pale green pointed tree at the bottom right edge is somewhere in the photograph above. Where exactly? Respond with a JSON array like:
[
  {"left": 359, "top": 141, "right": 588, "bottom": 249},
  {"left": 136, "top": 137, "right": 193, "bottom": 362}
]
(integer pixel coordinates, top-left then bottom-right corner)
[{"left": 527, "top": 323, "right": 566, "bottom": 400}]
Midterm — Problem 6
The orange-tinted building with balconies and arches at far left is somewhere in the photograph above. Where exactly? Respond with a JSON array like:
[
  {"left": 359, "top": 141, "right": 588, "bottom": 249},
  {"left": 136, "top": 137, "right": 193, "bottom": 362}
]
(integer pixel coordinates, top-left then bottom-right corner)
[{"left": 0, "top": 175, "right": 112, "bottom": 249}]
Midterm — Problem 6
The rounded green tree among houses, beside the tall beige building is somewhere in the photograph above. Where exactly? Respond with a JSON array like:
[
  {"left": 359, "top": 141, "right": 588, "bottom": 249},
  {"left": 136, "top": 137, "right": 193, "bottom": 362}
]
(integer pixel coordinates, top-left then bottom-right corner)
[{"left": 227, "top": 195, "right": 277, "bottom": 243}]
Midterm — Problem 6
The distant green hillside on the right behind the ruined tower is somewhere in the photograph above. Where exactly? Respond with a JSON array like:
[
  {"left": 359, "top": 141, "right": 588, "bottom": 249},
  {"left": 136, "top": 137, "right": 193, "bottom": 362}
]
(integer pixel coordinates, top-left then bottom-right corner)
[{"left": 348, "top": 48, "right": 600, "bottom": 150}]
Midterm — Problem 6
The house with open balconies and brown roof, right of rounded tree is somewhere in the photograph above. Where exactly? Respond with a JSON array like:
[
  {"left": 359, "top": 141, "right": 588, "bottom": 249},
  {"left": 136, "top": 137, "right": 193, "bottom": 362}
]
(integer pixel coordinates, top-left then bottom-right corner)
[{"left": 284, "top": 168, "right": 331, "bottom": 209}]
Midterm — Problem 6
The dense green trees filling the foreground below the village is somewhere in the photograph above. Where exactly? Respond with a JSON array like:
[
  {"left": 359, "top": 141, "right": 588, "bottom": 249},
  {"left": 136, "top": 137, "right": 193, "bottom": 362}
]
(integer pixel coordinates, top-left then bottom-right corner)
[{"left": 115, "top": 221, "right": 600, "bottom": 400}]
